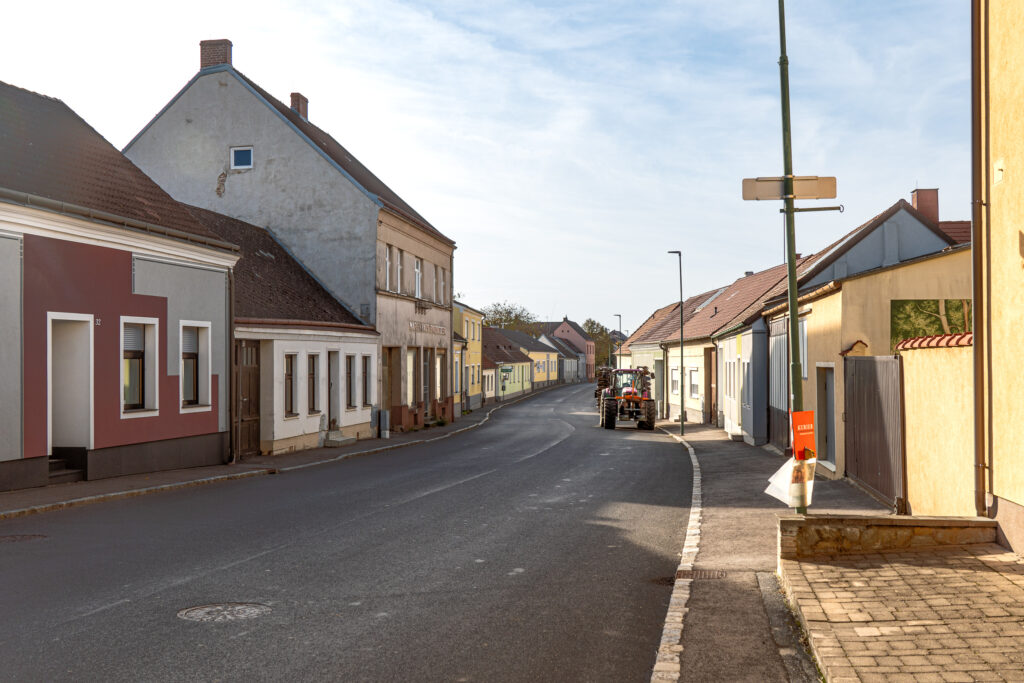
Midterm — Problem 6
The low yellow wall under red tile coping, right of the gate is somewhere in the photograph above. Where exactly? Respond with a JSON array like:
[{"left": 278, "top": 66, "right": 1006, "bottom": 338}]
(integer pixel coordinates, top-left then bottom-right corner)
[{"left": 900, "top": 346, "right": 975, "bottom": 516}]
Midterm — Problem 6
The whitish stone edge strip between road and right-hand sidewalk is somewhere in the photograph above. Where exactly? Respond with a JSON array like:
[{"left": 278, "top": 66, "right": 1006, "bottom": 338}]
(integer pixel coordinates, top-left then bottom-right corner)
[{"left": 650, "top": 427, "right": 702, "bottom": 683}]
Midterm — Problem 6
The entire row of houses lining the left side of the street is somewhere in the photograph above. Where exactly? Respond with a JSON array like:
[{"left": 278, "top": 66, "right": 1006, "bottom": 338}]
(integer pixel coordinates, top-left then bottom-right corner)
[{"left": 0, "top": 40, "right": 593, "bottom": 490}]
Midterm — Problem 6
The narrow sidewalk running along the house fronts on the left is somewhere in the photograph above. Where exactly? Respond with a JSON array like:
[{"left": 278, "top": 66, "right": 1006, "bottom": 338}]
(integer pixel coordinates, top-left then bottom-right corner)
[{"left": 0, "top": 393, "right": 524, "bottom": 519}]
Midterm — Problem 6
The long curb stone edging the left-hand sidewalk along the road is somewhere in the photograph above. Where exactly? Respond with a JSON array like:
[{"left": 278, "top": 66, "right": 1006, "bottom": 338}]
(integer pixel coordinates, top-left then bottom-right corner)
[{"left": 0, "top": 384, "right": 572, "bottom": 520}]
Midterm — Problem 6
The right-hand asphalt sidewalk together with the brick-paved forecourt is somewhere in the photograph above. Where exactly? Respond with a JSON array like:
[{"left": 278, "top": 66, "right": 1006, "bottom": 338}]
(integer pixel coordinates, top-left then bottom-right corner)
[{"left": 652, "top": 422, "right": 1024, "bottom": 683}]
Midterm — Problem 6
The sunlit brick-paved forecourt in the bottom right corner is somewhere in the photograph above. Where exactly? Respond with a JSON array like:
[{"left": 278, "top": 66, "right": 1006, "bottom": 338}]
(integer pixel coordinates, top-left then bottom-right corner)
[{"left": 780, "top": 544, "right": 1024, "bottom": 683}]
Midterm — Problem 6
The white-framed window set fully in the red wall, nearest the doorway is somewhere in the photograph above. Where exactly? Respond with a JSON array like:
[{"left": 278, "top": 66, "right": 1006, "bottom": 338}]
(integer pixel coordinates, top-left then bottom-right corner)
[{"left": 121, "top": 315, "right": 160, "bottom": 419}]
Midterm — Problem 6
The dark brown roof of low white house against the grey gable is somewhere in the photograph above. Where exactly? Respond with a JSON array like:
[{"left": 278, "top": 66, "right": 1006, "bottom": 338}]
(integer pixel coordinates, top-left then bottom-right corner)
[{"left": 188, "top": 202, "right": 362, "bottom": 325}]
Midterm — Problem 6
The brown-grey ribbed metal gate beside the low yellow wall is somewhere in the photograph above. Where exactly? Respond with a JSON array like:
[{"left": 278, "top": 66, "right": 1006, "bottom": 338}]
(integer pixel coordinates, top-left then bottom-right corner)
[{"left": 844, "top": 355, "right": 906, "bottom": 512}]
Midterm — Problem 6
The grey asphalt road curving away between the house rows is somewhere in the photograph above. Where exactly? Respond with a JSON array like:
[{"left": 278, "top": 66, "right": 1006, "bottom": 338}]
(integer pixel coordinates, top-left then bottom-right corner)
[{"left": 0, "top": 385, "right": 691, "bottom": 682}]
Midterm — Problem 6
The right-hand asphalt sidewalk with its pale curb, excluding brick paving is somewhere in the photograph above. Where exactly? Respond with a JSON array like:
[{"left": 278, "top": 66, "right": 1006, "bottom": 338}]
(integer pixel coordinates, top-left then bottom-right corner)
[{"left": 651, "top": 422, "right": 884, "bottom": 683}]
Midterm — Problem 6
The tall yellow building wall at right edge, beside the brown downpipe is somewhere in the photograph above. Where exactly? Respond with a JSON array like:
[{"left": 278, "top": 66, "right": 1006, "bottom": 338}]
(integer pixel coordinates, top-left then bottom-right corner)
[{"left": 979, "top": 0, "right": 1024, "bottom": 511}]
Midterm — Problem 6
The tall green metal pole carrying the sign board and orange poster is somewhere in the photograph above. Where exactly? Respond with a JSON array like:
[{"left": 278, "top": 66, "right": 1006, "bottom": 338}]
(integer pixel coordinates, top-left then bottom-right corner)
[{"left": 778, "top": 0, "right": 807, "bottom": 514}]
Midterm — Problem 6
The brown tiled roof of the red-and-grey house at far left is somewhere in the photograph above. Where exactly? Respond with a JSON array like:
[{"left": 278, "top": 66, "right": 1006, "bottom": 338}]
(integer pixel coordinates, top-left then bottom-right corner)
[{"left": 0, "top": 82, "right": 227, "bottom": 247}]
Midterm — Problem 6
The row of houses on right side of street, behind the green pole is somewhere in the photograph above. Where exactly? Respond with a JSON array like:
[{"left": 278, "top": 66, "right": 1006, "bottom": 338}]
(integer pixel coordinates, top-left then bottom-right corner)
[{"left": 623, "top": 189, "right": 972, "bottom": 497}]
